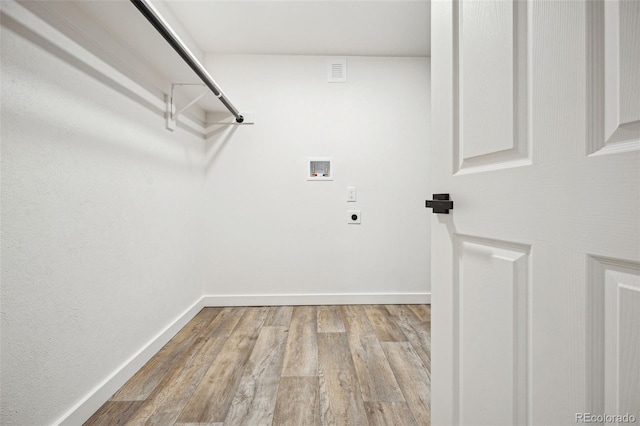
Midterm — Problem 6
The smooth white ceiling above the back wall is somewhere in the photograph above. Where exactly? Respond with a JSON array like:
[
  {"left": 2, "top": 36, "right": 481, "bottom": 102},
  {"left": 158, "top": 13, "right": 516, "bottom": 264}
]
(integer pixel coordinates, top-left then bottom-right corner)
[{"left": 165, "top": 0, "right": 430, "bottom": 56}]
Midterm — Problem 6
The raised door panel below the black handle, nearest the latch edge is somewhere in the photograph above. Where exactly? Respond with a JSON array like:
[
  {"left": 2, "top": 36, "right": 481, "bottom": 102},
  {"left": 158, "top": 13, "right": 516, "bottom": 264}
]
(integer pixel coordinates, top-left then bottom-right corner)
[{"left": 455, "top": 236, "right": 530, "bottom": 425}]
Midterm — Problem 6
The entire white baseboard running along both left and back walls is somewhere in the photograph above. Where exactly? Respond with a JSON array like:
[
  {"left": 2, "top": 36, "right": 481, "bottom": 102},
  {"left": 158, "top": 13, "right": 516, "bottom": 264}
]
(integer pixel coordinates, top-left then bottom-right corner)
[{"left": 55, "top": 293, "right": 431, "bottom": 425}]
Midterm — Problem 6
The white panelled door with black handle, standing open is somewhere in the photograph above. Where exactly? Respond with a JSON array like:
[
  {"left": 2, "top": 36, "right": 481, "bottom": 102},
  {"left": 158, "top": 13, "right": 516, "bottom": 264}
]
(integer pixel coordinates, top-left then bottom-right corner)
[{"left": 428, "top": 0, "right": 640, "bottom": 426}]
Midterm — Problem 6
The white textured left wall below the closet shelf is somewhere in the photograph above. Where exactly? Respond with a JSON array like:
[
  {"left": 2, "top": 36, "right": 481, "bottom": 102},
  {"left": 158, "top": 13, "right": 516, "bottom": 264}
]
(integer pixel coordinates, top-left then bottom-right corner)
[{"left": 0, "top": 5, "right": 204, "bottom": 425}]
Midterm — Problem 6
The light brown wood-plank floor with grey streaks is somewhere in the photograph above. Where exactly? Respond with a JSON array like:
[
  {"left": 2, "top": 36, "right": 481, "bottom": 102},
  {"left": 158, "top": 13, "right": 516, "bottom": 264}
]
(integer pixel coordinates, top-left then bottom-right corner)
[{"left": 85, "top": 305, "right": 431, "bottom": 426}]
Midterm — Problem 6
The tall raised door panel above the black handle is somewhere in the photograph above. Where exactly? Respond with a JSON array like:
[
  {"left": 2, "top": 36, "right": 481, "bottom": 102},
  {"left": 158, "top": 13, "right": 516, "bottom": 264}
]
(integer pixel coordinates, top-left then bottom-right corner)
[{"left": 454, "top": 0, "right": 530, "bottom": 173}]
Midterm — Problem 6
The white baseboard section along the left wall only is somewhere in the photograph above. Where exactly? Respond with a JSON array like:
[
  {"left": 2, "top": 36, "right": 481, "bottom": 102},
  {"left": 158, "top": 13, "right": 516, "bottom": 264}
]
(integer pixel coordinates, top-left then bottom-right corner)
[{"left": 55, "top": 298, "right": 204, "bottom": 425}]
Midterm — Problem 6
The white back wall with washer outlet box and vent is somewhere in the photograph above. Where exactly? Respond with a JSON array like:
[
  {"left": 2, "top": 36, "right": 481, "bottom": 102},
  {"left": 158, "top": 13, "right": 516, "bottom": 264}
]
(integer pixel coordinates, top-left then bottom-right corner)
[{"left": 205, "top": 55, "right": 431, "bottom": 304}]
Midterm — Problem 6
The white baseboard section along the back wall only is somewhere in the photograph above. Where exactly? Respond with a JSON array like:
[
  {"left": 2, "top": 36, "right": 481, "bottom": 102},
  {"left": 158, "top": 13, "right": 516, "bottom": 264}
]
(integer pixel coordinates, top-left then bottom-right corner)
[{"left": 202, "top": 293, "right": 431, "bottom": 306}]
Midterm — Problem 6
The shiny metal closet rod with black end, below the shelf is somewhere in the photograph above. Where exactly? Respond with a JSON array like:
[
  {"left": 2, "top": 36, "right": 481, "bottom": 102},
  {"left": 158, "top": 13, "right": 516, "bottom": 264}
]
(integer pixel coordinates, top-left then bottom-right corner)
[{"left": 131, "top": 0, "right": 244, "bottom": 123}]
